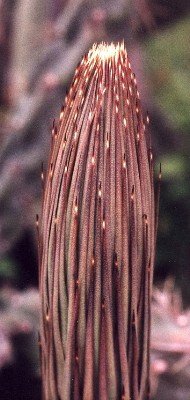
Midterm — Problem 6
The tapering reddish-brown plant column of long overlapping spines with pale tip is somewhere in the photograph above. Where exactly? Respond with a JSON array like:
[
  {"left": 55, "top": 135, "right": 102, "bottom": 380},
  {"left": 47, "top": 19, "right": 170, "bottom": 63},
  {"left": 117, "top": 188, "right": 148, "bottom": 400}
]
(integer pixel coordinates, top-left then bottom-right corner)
[{"left": 37, "top": 44, "right": 155, "bottom": 400}]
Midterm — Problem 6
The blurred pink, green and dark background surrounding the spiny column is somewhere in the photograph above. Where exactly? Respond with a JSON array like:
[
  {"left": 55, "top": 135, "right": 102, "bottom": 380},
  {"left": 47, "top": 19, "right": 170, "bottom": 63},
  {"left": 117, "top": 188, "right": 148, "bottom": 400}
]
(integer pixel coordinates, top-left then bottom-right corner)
[{"left": 0, "top": 0, "right": 190, "bottom": 400}]
